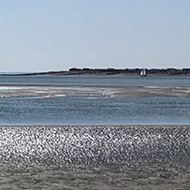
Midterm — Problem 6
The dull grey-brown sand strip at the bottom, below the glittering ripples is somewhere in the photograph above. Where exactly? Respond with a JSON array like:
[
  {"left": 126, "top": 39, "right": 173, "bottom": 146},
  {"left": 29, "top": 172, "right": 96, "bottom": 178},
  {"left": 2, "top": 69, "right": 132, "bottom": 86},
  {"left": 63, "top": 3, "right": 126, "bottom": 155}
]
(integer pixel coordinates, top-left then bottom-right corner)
[{"left": 0, "top": 167, "right": 190, "bottom": 190}]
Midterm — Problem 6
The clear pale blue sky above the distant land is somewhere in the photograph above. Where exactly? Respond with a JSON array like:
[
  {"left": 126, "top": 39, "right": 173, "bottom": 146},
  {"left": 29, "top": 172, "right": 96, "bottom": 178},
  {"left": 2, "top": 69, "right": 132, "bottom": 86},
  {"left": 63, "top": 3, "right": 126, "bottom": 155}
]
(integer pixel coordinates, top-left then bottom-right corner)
[{"left": 0, "top": 0, "right": 190, "bottom": 72}]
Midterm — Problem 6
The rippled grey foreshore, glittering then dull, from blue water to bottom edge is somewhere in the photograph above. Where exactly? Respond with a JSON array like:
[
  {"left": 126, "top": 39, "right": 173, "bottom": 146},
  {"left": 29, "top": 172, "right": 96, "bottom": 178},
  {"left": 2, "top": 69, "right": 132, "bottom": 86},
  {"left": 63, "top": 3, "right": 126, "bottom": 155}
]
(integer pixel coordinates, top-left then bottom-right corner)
[{"left": 0, "top": 125, "right": 190, "bottom": 190}]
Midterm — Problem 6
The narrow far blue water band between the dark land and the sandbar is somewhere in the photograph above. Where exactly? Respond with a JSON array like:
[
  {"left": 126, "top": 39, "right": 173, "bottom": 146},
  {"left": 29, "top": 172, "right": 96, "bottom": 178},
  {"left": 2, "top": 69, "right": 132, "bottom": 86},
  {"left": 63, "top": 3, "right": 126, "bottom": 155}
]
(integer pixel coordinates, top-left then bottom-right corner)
[{"left": 0, "top": 76, "right": 190, "bottom": 87}]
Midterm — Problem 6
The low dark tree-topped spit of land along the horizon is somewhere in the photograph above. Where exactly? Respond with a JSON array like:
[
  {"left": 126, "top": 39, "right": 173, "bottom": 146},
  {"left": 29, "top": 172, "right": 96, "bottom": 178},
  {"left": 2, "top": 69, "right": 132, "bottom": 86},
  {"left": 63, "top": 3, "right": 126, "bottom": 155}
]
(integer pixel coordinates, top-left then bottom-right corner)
[{"left": 1, "top": 68, "right": 190, "bottom": 76}]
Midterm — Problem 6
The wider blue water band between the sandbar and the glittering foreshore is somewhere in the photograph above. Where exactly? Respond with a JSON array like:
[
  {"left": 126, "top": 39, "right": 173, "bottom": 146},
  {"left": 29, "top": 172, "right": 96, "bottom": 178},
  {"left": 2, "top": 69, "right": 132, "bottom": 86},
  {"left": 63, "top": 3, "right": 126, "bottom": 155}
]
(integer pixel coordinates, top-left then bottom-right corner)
[{"left": 0, "top": 97, "right": 190, "bottom": 125}]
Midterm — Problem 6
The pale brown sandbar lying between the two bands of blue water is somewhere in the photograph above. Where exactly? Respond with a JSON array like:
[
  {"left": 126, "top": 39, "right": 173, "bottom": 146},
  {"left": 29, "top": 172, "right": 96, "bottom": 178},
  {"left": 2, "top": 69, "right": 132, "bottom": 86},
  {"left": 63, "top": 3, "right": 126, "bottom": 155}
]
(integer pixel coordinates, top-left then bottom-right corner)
[{"left": 0, "top": 86, "right": 190, "bottom": 98}]
